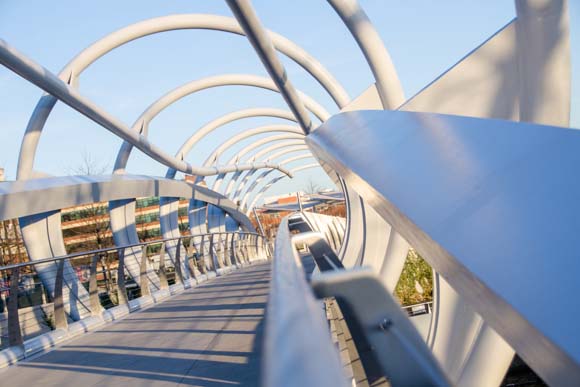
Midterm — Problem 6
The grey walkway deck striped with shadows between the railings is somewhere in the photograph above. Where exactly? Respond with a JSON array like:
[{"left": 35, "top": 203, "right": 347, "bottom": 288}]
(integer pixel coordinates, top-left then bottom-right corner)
[{"left": 0, "top": 263, "right": 270, "bottom": 387}]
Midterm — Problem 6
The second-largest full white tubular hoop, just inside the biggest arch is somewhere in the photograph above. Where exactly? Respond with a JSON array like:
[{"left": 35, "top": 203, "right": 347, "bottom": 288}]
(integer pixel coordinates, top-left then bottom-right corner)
[{"left": 114, "top": 74, "right": 330, "bottom": 173}]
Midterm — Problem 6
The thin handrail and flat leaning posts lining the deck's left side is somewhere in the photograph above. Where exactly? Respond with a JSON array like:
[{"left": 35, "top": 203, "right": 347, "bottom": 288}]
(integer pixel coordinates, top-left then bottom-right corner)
[{"left": 0, "top": 231, "right": 270, "bottom": 347}]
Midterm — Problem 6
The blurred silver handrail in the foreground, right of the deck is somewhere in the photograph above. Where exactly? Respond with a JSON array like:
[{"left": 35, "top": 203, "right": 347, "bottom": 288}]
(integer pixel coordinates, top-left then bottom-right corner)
[{"left": 262, "top": 217, "right": 347, "bottom": 387}]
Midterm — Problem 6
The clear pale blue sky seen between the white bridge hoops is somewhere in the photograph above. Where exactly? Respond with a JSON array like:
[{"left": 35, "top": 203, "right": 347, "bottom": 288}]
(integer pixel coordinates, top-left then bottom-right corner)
[{"left": 0, "top": 0, "right": 580, "bottom": 202}]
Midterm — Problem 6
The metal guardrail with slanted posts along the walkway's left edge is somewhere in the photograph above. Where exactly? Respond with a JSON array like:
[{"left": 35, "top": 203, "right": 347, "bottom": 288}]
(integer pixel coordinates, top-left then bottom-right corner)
[{"left": 0, "top": 232, "right": 270, "bottom": 363}]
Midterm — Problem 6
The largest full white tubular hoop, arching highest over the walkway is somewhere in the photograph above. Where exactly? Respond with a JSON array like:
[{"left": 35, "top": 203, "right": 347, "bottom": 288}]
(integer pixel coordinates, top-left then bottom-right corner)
[{"left": 17, "top": 14, "right": 350, "bottom": 180}]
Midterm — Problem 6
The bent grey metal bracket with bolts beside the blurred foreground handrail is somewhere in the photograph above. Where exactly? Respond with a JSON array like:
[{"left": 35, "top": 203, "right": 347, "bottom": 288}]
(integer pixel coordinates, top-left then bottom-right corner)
[{"left": 311, "top": 269, "right": 450, "bottom": 386}]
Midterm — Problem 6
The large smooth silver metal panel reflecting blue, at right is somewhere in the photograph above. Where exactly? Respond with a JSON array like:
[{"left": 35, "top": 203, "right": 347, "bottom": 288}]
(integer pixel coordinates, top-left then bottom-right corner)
[{"left": 307, "top": 111, "right": 580, "bottom": 383}]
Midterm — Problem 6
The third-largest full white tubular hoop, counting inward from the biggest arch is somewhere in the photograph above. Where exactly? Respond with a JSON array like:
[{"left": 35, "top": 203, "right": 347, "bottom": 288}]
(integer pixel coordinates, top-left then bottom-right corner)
[{"left": 165, "top": 108, "right": 296, "bottom": 179}]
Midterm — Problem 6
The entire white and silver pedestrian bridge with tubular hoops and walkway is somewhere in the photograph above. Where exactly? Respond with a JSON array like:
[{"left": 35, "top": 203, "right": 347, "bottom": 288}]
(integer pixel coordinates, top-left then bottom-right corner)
[{"left": 0, "top": 0, "right": 580, "bottom": 387}]
